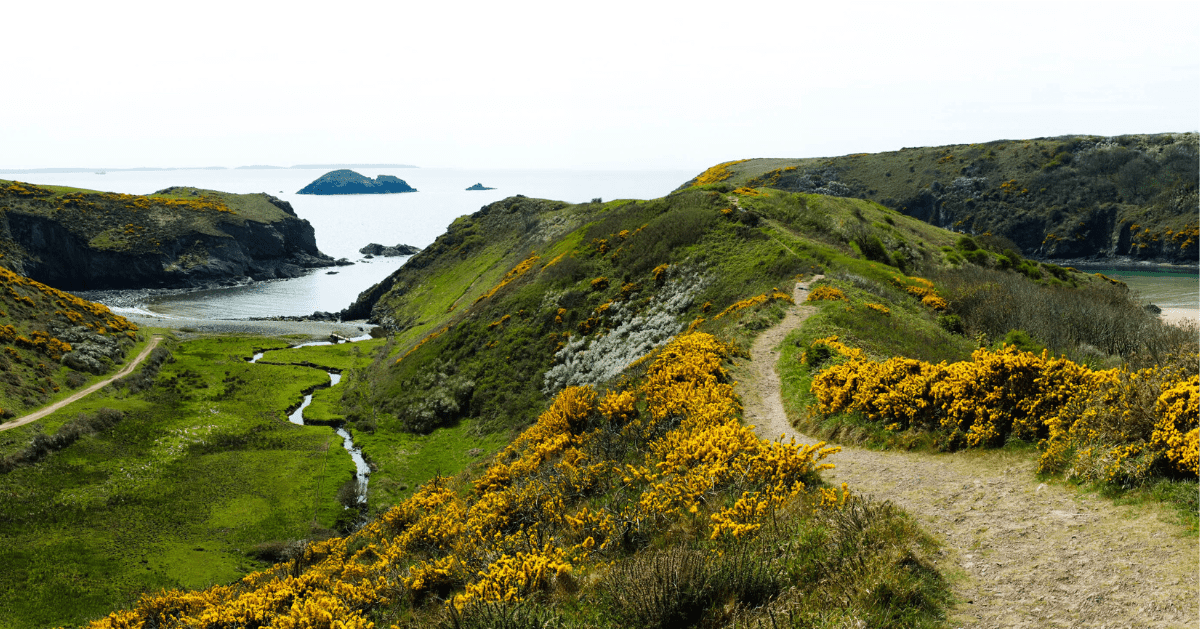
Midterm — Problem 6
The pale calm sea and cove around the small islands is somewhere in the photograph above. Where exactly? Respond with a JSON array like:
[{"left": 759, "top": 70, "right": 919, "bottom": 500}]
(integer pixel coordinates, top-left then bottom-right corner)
[{"left": 21, "top": 168, "right": 696, "bottom": 319}]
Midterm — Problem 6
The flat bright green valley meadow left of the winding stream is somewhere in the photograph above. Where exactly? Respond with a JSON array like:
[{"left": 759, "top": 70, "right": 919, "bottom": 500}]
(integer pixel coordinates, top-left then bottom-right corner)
[{"left": 0, "top": 337, "right": 354, "bottom": 628}]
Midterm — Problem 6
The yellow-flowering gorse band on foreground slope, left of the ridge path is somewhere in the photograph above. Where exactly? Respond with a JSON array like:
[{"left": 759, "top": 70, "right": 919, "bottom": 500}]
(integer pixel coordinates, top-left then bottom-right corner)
[{"left": 94, "top": 332, "right": 848, "bottom": 628}]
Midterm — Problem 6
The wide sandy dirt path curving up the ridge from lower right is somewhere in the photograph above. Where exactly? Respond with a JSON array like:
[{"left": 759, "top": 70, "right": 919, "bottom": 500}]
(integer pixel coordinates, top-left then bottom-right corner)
[{"left": 739, "top": 284, "right": 1200, "bottom": 628}]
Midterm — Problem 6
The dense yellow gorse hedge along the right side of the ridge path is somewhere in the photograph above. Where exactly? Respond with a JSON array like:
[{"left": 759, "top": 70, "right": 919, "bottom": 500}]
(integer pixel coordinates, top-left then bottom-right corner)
[{"left": 811, "top": 337, "right": 1200, "bottom": 486}]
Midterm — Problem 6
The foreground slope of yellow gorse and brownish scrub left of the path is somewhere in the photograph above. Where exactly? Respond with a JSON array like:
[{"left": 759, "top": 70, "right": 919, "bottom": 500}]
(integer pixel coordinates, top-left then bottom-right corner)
[{"left": 96, "top": 332, "right": 947, "bottom": 628}]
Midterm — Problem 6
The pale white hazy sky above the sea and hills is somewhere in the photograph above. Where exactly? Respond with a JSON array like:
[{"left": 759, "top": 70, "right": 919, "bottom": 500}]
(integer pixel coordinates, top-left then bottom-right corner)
[{"left": 0, "top": 0, "right": 1200, "bottom": 170}]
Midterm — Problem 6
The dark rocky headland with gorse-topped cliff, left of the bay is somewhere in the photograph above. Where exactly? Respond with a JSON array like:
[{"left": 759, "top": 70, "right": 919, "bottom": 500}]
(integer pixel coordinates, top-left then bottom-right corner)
[{"left": 0, "top": 181, "right": 336, "bottom": 290}]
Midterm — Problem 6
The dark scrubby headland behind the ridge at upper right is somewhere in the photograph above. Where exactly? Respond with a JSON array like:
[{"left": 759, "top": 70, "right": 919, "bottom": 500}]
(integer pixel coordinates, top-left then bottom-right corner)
[{"left": 685, "top": 133, "right": 1200, "bottom": 266}]
